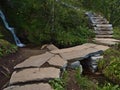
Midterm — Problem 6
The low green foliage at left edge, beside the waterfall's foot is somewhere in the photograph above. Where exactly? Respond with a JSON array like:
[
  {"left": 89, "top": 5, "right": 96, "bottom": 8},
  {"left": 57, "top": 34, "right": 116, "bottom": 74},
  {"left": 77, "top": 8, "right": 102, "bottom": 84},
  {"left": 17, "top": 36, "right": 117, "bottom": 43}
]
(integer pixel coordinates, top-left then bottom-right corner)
[{"left": 0, "top": 39, "right": 17, "bottom": 57}]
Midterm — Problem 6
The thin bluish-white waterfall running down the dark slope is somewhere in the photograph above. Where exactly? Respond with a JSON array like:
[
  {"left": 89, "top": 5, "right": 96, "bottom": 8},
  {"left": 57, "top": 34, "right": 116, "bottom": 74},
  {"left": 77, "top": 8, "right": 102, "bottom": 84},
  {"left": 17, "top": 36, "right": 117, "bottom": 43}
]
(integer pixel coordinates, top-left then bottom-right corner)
[{"left": 0, "top": 10, "right": 25, "bottom": 47}]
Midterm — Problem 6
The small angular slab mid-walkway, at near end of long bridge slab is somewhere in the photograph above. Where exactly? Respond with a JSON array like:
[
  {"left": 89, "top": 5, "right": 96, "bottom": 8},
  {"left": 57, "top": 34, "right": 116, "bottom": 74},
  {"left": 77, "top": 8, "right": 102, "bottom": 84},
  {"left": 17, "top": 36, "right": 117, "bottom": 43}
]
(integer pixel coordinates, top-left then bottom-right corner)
[{"left": 48, "top": 55, "right": 67, "bottom": 67}]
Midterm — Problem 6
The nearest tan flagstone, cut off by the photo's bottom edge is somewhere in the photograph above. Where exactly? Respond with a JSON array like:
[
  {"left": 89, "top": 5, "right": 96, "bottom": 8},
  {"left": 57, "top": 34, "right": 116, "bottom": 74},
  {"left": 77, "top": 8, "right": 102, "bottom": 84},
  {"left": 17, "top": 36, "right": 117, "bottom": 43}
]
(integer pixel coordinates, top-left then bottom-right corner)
[{"left": 4, "top": 83, "right": 53, "bottom": 90}]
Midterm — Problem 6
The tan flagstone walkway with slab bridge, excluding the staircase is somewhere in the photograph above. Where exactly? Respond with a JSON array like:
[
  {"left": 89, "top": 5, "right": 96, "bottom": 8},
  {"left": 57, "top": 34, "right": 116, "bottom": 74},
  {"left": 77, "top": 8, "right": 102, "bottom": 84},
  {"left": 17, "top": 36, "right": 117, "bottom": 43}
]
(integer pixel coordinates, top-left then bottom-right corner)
[{"left": 3, "top": 43, "right": 109, "bottom": 90}]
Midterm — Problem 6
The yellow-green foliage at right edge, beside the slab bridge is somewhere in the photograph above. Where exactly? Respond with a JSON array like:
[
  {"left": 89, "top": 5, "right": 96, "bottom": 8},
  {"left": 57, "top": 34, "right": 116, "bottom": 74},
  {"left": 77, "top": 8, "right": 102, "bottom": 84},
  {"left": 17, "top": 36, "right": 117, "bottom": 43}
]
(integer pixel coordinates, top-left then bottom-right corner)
[{"left": 98, "top": 47, "right": 120, "bottom": 83}]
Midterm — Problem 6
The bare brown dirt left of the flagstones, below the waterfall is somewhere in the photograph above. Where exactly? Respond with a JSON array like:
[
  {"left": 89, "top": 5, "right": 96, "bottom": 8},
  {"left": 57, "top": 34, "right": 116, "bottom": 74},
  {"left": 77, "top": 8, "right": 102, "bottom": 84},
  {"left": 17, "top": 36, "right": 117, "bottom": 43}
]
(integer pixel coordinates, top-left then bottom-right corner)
[{"left": 0, "top": 47, "right": 46, "bottom": 90}]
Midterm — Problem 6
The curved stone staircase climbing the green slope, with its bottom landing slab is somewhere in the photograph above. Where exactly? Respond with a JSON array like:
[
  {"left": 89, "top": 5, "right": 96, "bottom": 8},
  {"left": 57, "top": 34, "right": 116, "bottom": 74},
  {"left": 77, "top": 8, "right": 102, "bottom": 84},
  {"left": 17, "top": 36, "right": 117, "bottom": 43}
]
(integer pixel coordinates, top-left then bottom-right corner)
[{"left": 85, "top": 12, "right": 120, "bottom": 46}]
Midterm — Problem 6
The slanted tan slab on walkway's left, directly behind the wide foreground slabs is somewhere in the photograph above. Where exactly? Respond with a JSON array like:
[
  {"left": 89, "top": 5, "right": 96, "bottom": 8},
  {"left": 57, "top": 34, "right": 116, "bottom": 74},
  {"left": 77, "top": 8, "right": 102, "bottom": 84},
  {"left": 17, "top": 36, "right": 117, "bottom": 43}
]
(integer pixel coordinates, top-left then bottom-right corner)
[{"left": 14, "top": 52, "right": 54, "bottom": 69}]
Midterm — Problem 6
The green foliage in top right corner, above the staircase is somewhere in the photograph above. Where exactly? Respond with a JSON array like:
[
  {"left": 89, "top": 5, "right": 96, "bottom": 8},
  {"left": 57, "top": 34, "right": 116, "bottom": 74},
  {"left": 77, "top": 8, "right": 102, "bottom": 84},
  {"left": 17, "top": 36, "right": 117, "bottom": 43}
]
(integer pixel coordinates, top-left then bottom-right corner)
[{"left": 82, "top": 0, "right": 120, "bottom": 26}]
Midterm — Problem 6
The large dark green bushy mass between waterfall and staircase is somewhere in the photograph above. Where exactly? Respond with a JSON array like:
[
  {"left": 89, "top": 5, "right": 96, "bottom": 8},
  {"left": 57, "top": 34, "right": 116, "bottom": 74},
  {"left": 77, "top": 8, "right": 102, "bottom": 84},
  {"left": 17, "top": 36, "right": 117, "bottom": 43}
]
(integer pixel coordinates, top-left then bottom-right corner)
[{"left": 8, "top": 0, "right": 93, "bottom": 47}]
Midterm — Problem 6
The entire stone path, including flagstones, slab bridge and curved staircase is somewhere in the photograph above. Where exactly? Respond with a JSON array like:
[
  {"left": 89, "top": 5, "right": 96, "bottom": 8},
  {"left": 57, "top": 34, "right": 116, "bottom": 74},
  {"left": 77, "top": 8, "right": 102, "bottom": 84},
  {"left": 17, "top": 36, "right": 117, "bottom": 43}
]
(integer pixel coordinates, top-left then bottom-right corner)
[{"left": 4, "top": 12, "right": 120, "bottom": 90}]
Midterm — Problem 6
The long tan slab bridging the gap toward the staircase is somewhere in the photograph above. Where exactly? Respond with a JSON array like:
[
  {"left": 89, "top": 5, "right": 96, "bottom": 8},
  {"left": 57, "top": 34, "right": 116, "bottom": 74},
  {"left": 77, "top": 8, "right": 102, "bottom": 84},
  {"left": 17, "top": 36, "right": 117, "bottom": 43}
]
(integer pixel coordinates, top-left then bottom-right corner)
[{"left": 60, "top": 45, "right": 109, "bottom": 61}]
